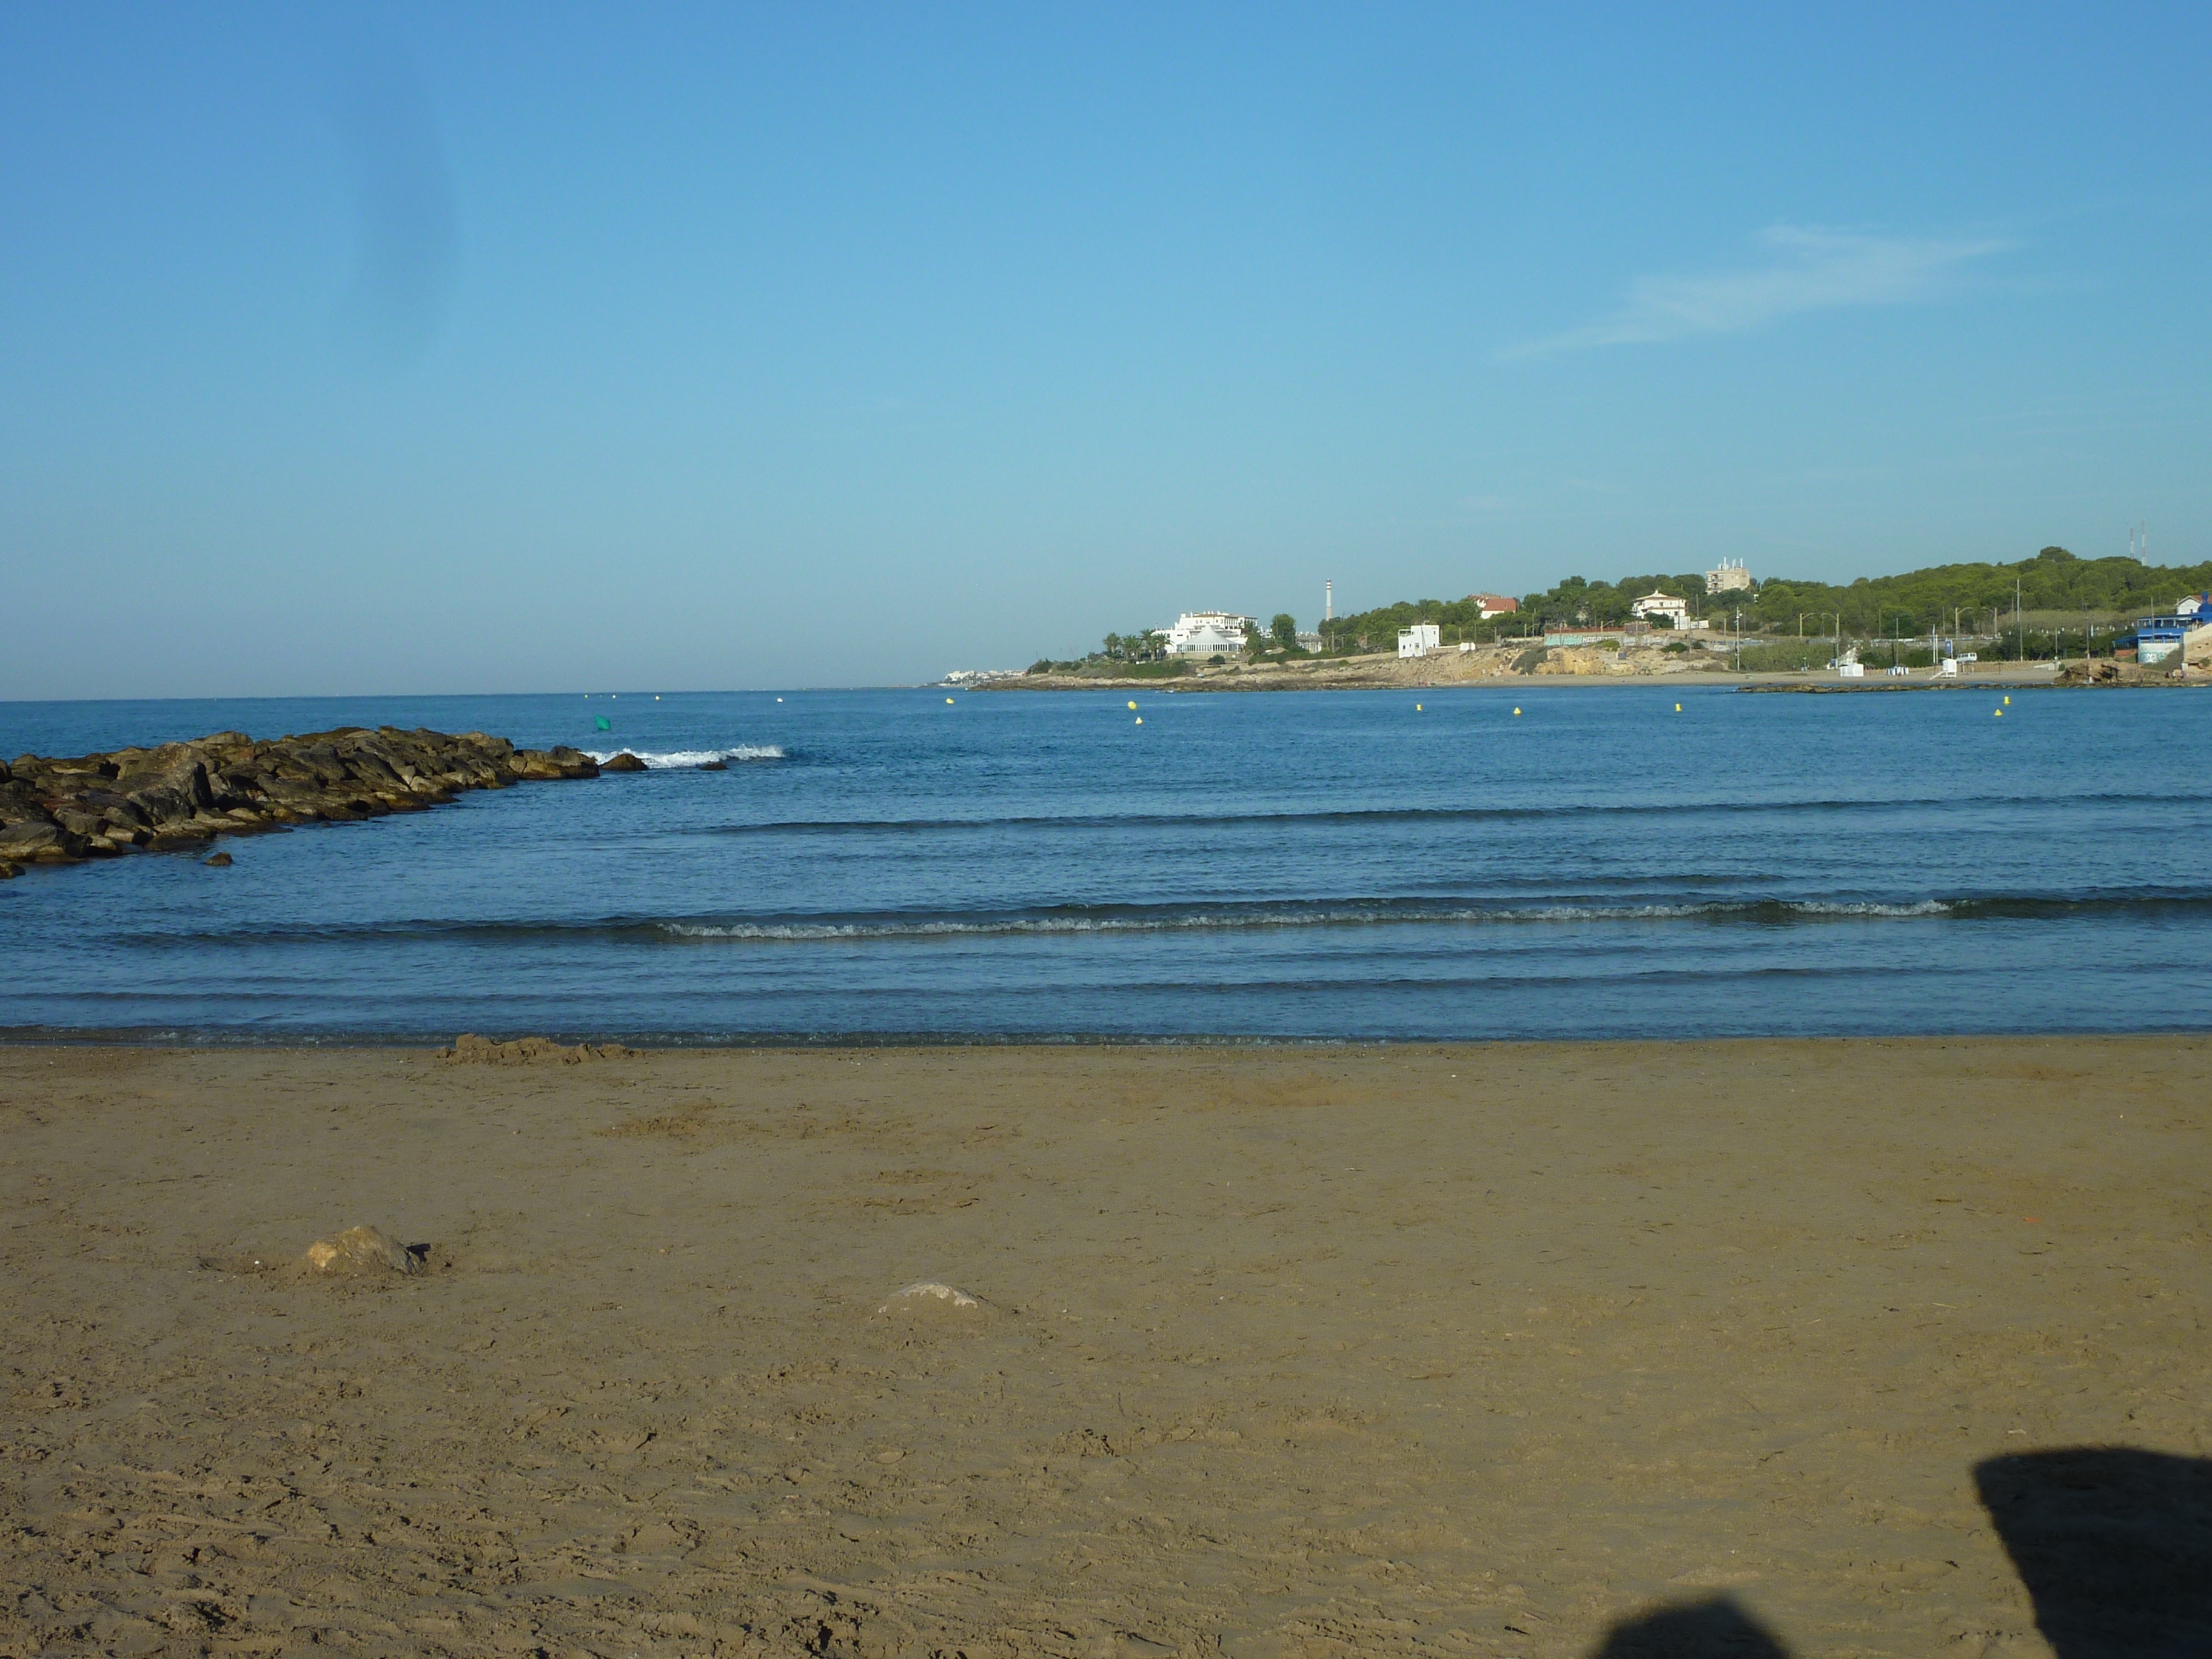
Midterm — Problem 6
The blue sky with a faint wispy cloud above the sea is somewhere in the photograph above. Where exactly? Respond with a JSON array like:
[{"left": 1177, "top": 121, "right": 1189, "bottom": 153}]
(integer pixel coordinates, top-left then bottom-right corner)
[{"left": 0, "top": 0, "right": 2212, "bottom": 697}]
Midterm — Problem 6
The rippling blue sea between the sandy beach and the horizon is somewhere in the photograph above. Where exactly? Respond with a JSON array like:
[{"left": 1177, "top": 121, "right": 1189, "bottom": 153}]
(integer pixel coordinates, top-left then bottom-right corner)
[{"left": 0, "top": 683, "right": 2212, "bottom": 1042}]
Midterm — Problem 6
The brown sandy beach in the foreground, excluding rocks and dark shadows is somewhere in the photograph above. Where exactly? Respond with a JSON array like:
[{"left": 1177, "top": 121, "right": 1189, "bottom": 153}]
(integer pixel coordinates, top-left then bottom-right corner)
[{"left": 0, "top": 1040, "right": 2212, "bottom": 1659}]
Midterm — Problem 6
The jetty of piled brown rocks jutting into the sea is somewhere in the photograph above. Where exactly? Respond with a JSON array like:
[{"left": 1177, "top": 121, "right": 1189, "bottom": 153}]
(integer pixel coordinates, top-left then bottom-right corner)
[{"left": 0, "top": 726, "right": 600, "bottom": 876}]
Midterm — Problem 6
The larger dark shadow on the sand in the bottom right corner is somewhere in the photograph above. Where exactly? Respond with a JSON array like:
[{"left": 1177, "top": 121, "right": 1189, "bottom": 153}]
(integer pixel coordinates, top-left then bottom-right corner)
[{"left": 1973, "top": 1447, "right": 2212, "bottom": 1659}]
